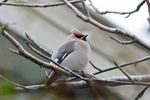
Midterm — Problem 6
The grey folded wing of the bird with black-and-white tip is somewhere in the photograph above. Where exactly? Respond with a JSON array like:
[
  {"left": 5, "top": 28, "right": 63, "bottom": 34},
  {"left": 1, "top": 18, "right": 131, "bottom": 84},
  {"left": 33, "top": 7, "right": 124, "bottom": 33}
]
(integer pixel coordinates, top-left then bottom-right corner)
[{"left": 52, "top": 41, "right": 75, "bottom": 63}]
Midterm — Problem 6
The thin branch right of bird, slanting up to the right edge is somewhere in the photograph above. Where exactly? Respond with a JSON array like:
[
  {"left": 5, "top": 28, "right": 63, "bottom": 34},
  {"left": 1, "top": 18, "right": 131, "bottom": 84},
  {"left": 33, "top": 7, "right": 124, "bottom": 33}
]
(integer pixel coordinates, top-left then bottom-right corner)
[{"left": 94, "top": 56, "right": 150, "bottom": 75}]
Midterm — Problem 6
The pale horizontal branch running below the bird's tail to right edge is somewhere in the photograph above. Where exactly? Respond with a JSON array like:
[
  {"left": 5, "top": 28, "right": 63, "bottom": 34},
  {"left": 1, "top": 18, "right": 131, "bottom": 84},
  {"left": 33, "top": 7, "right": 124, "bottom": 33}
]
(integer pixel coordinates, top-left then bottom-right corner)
[{"left": 16, "top": 75, "right": 150, "bottom": 90}]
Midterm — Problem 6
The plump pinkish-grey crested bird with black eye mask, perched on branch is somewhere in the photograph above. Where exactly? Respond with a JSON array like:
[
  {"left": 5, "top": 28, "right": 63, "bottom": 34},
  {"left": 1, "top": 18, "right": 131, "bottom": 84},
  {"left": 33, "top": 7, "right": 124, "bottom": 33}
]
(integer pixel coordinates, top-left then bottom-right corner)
[{"left": 45, "top": 29, "right": 91, "bottom": 88}]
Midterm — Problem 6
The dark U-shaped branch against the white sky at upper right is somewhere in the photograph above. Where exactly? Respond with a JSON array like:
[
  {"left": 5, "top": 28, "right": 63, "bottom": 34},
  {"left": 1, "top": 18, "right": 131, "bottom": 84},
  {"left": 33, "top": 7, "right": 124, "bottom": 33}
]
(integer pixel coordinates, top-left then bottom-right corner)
[{"left": 89, "top": 0, "right": 145, "bottom": 18}]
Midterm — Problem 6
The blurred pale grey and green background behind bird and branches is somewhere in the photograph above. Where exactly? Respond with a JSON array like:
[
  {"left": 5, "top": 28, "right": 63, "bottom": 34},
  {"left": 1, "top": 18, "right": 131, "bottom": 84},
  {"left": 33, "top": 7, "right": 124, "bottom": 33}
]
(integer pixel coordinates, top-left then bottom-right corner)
[{"left": 0, "top": 0, "right": 150, "bottom": 100}]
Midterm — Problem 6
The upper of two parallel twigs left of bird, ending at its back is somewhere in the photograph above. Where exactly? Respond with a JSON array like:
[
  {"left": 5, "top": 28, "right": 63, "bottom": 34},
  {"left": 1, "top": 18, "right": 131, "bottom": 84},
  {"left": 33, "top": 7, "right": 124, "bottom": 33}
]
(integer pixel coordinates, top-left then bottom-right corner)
[{"left": 25, "top": 33, "right": 52, "bottom": 56}]
